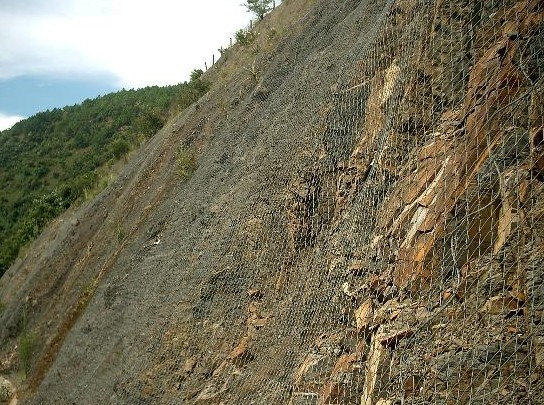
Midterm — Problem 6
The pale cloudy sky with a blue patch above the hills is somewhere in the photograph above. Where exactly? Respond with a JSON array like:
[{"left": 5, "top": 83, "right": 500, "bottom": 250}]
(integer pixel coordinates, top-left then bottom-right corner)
[{"left": 0, "top": 0, "right": 251, "bottom": 130}]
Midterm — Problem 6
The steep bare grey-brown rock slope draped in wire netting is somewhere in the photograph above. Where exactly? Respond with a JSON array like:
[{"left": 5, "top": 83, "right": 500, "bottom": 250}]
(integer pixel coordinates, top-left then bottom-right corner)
[{"left": 0, "top": 0, "right": 544, "bottom": 405}]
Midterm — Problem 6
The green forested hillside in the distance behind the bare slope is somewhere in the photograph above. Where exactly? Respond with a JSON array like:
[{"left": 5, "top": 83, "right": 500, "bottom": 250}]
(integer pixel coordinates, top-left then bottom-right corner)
[{"left": 0, "top": 71, "right": 208, "bottom": 276}]
